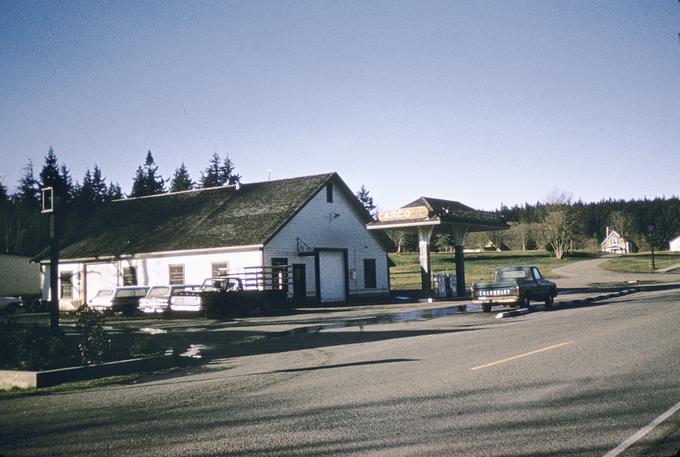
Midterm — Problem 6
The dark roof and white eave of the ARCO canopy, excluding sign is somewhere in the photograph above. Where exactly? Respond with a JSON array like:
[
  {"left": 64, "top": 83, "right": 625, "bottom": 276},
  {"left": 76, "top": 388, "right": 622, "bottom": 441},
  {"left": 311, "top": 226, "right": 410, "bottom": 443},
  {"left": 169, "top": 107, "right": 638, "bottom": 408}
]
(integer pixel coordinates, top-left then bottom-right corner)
[{"left": 369, "top": 197, "right": 509, "bottom": 231}]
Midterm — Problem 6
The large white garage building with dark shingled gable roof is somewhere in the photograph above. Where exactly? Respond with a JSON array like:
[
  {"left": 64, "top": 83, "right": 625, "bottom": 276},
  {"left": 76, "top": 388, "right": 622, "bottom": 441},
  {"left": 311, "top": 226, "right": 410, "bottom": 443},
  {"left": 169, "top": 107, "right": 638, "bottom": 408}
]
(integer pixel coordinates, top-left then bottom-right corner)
[{"left": 36, "top": 173, "right": 390, "bottom": 310}]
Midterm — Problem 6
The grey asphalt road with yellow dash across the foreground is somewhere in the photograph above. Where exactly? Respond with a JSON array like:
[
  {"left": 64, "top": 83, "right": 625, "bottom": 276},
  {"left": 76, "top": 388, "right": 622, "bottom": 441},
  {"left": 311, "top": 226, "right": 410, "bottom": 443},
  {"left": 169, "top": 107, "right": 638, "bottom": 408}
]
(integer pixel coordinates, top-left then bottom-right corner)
[{"left": 0, "top": 290, "right": 680, "bottom": 456}]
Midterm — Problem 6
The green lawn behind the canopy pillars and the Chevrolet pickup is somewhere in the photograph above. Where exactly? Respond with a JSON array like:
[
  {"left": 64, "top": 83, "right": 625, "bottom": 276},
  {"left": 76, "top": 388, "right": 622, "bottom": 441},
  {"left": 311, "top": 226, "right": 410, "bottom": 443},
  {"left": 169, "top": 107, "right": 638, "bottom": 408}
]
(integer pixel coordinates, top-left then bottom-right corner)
[{"left": 390, "top": 251, "right": 598, "bottom": 290}]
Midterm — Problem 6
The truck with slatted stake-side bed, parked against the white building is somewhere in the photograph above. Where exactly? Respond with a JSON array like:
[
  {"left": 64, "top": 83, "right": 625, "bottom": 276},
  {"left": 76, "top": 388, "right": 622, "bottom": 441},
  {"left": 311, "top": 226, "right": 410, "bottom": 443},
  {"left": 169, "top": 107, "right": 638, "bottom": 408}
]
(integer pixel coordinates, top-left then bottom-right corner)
[{"left": 170, "top": 276, "right": 287, "bottom": 317}]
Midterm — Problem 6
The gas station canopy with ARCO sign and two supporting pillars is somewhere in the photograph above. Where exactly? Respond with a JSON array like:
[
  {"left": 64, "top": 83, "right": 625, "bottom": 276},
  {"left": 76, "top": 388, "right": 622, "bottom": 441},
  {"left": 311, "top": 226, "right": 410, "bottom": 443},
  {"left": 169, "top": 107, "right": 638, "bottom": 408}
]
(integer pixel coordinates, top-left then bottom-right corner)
[{"left": 366, "top": 197, "right": 509, "bottom": 296}]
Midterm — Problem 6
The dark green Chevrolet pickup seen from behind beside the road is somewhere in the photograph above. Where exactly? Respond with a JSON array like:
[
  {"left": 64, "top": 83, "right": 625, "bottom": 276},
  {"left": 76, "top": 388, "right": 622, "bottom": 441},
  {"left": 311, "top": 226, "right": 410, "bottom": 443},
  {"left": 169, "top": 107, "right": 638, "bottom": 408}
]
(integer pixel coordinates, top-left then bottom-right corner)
[{"left": 472, "top": 266, "right": 557, "bottom": 313}]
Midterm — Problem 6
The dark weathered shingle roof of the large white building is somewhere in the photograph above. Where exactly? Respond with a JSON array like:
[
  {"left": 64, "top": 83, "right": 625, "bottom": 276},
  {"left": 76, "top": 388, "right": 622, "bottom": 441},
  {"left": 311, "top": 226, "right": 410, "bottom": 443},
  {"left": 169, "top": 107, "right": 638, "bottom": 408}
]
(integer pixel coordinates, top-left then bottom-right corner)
[{"left": 34, "top": 173, "right": 390, "bottom": 260}]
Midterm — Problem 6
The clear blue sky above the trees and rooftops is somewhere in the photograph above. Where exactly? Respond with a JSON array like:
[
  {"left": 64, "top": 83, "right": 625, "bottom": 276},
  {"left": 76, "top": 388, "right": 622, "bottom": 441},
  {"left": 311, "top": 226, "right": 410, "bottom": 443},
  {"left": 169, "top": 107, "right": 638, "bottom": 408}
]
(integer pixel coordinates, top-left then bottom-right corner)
[{"left": 0, "top": 0, "right": 680, "bottom": 209}]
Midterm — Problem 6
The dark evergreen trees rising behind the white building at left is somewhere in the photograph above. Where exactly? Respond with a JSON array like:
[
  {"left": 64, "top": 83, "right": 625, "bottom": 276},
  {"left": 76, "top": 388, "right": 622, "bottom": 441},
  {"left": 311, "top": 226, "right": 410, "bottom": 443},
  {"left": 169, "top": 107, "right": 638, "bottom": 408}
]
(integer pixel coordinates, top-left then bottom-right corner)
[{"left": 0, "top": 147, "right": 241, "bottom": 256}]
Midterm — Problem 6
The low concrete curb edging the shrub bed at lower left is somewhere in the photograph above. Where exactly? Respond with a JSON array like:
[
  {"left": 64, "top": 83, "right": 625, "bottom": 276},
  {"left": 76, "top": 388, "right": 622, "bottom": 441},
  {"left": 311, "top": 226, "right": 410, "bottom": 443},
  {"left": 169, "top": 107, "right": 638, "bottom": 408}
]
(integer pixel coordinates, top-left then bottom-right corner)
[{"left": 0, "top": 354, "right": 202, "bottom": 390}]
